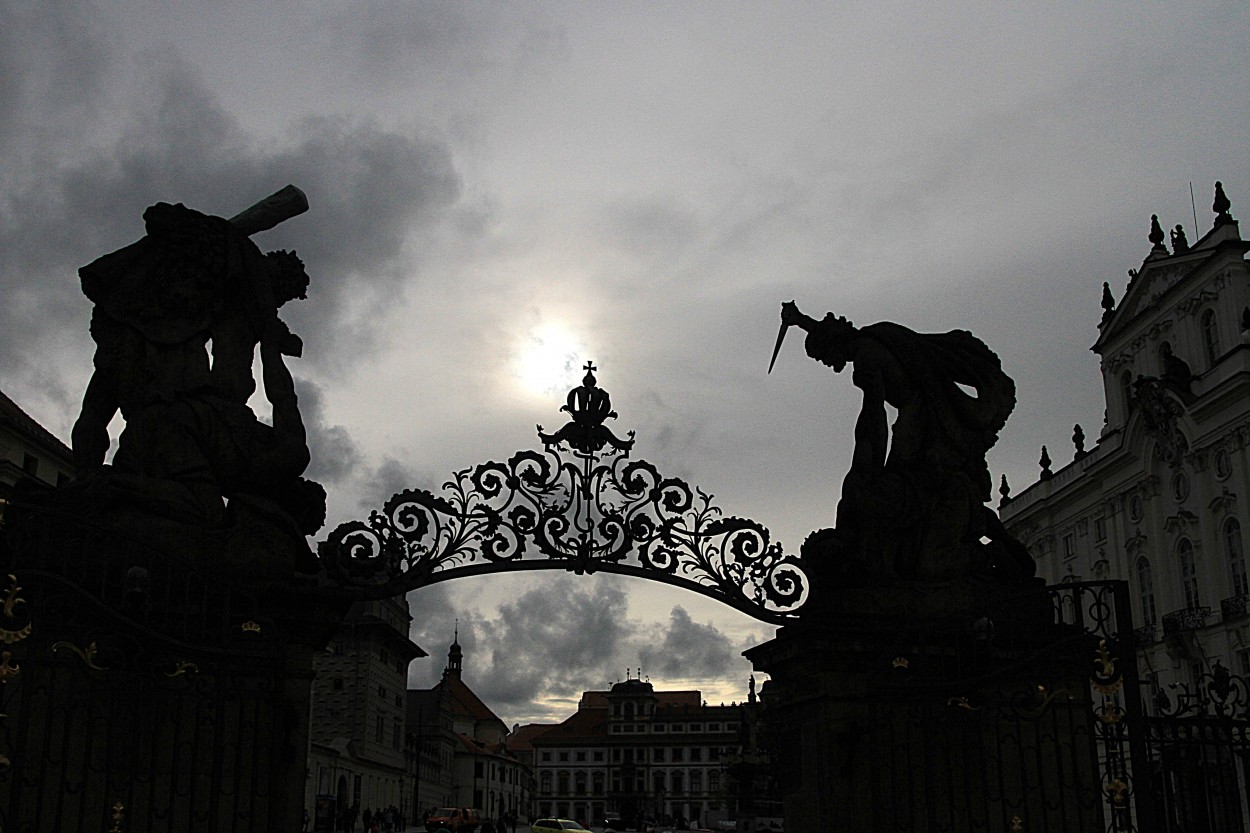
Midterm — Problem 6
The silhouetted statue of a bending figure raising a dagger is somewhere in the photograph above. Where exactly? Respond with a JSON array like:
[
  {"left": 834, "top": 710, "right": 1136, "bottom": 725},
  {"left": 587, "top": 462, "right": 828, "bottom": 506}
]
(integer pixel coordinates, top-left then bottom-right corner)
[{"left": 774, "top": 301, "right": 1035, "bottom": 584}]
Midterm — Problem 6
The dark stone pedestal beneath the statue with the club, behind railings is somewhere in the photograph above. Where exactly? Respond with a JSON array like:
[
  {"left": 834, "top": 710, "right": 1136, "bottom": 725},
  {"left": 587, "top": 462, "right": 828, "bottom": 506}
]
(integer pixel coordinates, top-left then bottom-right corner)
[{"left": 0, "top": 495, "right": 348, "bottom": 833}]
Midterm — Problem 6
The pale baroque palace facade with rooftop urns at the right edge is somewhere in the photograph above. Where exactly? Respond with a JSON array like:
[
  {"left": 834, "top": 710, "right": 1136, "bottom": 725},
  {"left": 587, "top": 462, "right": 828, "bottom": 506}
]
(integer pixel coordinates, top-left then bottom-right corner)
[{"left": 1000, "top": 183, "right": 1250, "bottom": 703}]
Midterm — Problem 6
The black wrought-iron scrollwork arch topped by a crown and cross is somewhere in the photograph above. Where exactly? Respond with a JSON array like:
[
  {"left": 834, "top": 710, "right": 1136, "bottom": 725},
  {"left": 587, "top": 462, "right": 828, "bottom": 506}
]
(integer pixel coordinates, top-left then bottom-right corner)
[{"left": 320, "top": 363, "right": 809, "bottom": 623}]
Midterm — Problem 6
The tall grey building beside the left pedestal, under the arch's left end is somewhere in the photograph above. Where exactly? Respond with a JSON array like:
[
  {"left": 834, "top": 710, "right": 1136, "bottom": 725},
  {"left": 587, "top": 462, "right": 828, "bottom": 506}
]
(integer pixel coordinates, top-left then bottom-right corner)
[{"left": 305, "top": 597, "right": 426, "bottom": 818}]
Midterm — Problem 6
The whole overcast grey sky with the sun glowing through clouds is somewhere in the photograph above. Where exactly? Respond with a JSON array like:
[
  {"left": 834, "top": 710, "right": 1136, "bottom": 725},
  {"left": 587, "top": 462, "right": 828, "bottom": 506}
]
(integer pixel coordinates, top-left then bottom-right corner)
[{"left": 0, "top": 0, "right": 1250, "bottom": 723}]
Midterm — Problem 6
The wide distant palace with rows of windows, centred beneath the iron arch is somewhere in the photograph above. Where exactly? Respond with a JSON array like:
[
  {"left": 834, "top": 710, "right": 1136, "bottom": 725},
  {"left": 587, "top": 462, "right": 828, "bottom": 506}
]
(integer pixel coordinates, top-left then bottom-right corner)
[{"left": 529, "top": 679, "right": 746, "bottom": 824}]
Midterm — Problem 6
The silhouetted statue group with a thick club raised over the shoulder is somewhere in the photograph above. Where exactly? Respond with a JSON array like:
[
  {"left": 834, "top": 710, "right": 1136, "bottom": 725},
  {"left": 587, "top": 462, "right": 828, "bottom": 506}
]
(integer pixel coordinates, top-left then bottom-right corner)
[{"left": 66, "top": 186, "right": 325, "bottom": 570}]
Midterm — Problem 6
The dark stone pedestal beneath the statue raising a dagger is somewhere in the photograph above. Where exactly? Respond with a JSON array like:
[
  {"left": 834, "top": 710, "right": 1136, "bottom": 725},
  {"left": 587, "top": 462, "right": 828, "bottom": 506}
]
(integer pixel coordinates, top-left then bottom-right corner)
[{"left": 746, "top": 588, "right": 1106, "bottom": 833}]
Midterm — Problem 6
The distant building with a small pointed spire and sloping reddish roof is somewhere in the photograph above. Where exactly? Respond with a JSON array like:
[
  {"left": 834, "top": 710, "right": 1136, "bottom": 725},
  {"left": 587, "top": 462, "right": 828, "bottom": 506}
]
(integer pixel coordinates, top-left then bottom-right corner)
[{"left": 408, "top": 634, "right": 531, "bottom": 823}]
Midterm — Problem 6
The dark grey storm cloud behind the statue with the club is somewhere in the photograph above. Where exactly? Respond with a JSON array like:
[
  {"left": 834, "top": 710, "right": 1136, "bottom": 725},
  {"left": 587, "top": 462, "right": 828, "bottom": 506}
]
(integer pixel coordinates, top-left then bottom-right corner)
[{"left": 0, "top": 48, "right": 460, "bottom": 400}]
